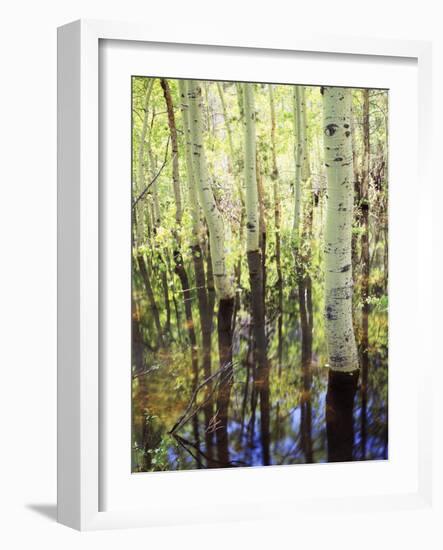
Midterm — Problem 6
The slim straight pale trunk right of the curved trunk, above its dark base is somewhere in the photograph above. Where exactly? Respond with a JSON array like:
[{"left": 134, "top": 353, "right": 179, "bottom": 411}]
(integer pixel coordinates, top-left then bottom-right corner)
[{"left": 243, "top": 84, "right": 259, "bottom": 252}]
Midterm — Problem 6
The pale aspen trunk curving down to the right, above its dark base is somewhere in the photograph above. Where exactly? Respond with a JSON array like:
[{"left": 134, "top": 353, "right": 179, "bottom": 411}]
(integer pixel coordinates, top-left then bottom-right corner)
[{"left": 188, "top": 80, "right": 234, "bottom": 299}]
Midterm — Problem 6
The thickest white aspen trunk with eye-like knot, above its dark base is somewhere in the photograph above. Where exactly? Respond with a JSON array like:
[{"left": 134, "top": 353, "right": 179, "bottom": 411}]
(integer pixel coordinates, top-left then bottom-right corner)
[{"left": 322, "top": 87, "right": 358, "bottom": 372}]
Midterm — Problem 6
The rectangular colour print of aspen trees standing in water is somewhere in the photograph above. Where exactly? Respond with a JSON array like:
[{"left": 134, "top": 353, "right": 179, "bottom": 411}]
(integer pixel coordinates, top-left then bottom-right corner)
[{"left": 128, "top": 76, "right": 389, "bottom": 473}]
